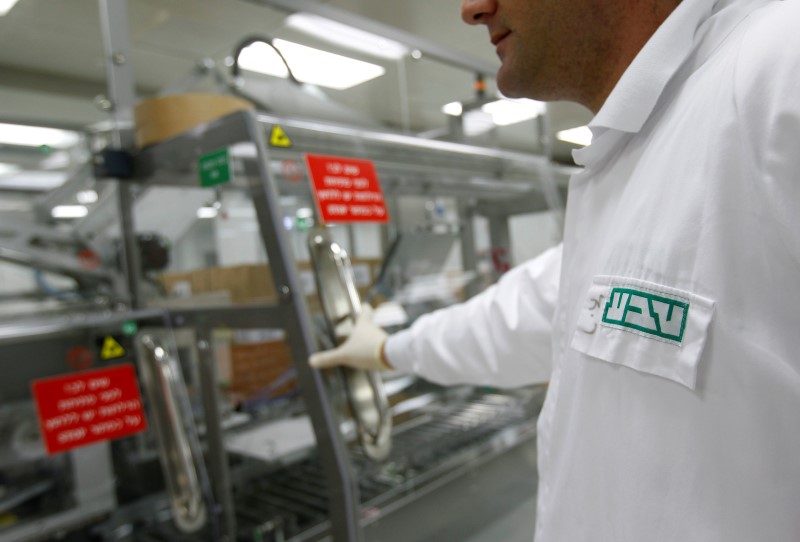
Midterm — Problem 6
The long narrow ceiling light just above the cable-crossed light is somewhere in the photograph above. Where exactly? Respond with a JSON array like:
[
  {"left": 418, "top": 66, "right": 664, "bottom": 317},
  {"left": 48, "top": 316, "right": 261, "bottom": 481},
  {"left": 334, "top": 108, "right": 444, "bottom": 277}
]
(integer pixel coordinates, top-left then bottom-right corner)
[{"left": 281, "top": 13, "right": 410, "bottom": 60}]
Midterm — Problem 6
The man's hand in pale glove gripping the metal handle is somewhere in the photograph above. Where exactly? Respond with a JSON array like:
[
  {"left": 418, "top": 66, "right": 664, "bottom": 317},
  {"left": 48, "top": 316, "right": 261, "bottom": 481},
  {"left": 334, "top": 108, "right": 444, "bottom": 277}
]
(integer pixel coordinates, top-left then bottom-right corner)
[{"left": 308, "top": 303, "right": 392, "bottom": 371}]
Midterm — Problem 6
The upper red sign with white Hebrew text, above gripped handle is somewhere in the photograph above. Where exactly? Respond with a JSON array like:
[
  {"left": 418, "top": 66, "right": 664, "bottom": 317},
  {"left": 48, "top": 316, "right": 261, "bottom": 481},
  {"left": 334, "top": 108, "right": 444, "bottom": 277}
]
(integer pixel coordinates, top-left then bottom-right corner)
[{"left": 306, "top": 154, "right": 389, "bottom": 224}]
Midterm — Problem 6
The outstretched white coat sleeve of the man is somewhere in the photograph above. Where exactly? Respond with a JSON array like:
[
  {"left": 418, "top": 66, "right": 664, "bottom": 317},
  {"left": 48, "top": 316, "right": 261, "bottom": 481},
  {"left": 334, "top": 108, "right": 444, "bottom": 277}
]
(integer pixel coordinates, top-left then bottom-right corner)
[{"left": 385, "top": 245, "right": 561, "bottom": 387}]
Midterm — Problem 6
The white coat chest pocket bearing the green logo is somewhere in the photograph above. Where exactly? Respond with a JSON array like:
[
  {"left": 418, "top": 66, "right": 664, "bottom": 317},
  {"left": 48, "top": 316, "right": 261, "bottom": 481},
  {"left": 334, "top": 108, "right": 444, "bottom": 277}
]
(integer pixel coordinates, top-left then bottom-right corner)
[{"left": 571, "top": 275, "right": 714, "bottom": 390}]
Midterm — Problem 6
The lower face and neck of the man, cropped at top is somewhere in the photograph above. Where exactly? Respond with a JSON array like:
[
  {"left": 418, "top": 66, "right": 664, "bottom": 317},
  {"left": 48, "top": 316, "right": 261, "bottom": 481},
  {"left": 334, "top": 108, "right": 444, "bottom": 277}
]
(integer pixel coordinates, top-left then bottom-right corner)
[{"left": 461, "top": 0, "right": 621, "bottom": 107}]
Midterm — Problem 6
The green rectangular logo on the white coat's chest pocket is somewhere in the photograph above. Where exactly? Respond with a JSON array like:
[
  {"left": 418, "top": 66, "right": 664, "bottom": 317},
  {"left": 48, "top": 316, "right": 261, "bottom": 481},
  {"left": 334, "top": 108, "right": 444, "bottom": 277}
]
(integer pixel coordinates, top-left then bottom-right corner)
[{"left": 603, "top": 288, "right": 689, "bottom": 343}]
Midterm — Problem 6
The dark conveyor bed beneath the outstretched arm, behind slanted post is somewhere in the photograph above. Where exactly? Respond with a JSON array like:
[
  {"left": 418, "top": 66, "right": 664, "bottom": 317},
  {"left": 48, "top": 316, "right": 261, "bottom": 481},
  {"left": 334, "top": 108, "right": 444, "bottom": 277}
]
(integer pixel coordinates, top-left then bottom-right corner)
[{"left": 235, "top": 395, "right": 535, "bottom": 542}]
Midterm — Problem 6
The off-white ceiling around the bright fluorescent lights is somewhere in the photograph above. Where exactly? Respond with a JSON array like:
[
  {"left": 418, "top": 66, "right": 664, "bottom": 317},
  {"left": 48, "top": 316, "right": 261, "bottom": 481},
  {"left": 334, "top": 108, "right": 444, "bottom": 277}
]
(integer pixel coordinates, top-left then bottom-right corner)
[{"left": 0, "top": 0, "right": 590, "bottom": 161}]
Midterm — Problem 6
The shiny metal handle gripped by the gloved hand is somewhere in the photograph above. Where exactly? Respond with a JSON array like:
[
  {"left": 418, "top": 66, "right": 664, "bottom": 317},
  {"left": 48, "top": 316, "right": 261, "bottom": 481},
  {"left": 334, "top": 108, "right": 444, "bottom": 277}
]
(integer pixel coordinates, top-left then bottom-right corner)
[{"left": 308, "top": 229, "right": 392, "bottom": 460}]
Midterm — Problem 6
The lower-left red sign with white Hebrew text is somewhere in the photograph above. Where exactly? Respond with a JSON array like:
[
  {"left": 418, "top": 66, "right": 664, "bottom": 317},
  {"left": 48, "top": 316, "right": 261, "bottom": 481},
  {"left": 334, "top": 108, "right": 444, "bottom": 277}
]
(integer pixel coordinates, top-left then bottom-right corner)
[{"left": 31, "top": 363, "right": 147, "bottom": 455}]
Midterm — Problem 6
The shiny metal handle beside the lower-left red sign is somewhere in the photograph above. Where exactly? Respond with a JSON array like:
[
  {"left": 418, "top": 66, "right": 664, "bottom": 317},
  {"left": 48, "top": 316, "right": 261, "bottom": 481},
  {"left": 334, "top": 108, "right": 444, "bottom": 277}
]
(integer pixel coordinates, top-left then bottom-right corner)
[{"left": 139, "top": 334, "right": 206, "bottom": 533}]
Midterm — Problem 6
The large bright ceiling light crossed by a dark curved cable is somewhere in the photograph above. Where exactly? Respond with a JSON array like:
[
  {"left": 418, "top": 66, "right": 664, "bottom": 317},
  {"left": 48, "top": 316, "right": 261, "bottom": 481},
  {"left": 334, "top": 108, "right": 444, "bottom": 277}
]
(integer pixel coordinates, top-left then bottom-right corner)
[{"left": 239, "top": 39, "right": 386, "bottom": 90}]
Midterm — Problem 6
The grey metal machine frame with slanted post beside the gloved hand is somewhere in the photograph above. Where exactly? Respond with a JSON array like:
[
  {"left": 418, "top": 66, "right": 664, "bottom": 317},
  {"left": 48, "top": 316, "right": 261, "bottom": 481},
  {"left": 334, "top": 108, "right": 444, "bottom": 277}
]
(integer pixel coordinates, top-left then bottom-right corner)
[{"left": 130, "top": 108, "right": 559, "bottom": 541}]
